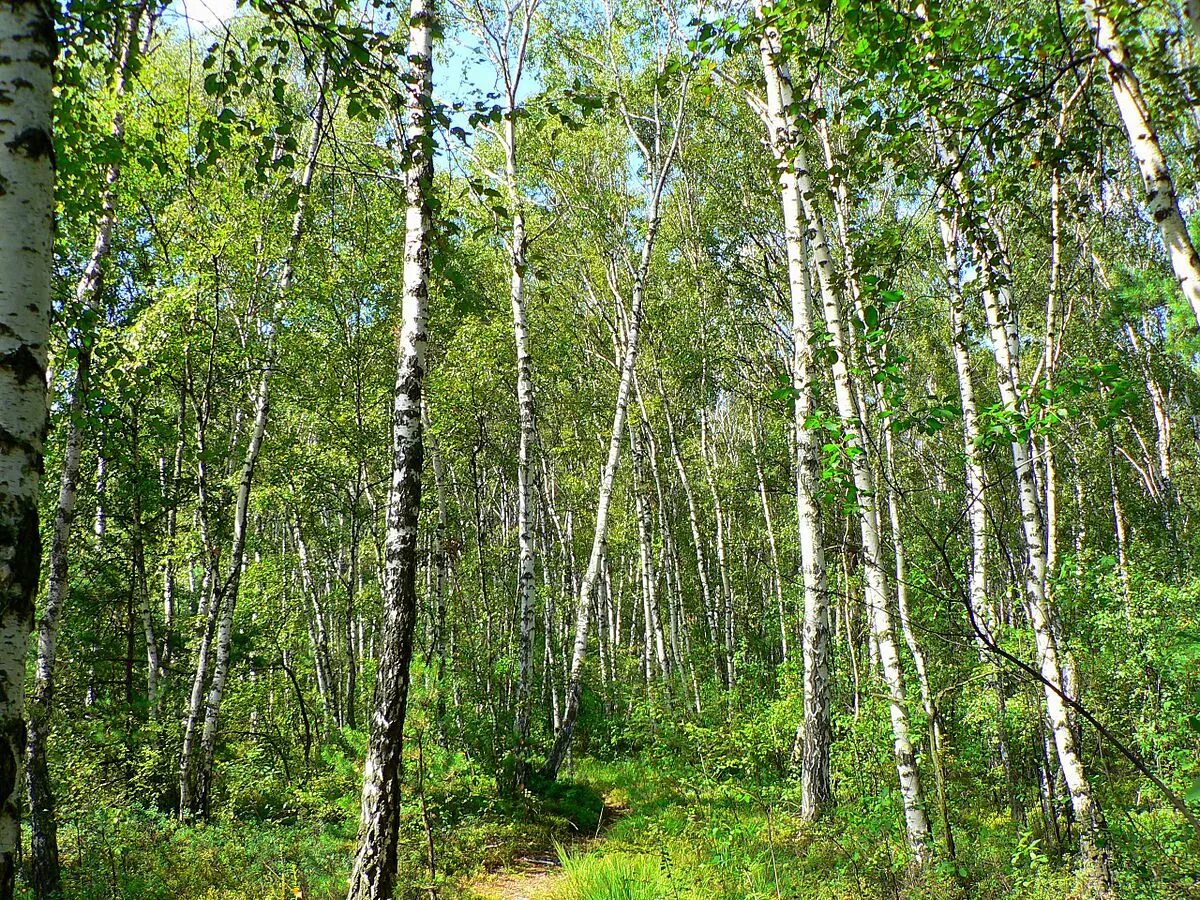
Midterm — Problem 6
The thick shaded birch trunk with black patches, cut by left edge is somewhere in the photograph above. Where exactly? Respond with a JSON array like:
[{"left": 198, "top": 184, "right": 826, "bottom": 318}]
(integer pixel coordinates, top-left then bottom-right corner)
[{"left": 0, "top": 0, "right": 58, "bottom": 900}]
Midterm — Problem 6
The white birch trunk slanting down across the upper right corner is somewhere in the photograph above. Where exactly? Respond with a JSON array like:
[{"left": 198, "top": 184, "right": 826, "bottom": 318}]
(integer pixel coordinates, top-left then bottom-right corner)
[{"left": 1082, "top": 0, "right": 1200, "bottom": 325}]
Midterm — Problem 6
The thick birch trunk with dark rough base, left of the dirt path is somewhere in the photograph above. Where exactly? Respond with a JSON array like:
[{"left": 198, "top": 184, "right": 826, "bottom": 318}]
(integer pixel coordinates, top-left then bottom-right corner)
[{"left": 347, "top": 0, "right": 436, "bottom": 900}]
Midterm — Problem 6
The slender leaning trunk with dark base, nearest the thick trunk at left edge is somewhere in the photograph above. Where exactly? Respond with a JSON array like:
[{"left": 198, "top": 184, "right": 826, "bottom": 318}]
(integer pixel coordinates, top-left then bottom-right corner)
[{"left": 25, "top": 0, "right": 146, "bottom": 896}]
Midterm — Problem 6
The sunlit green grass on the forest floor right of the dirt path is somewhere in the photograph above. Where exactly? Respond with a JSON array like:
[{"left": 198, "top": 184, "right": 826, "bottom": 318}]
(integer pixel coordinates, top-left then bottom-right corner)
[{"left": 552, "top": 760, "right": 1194, "bottom": 900}]
